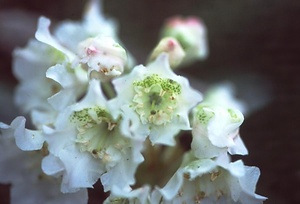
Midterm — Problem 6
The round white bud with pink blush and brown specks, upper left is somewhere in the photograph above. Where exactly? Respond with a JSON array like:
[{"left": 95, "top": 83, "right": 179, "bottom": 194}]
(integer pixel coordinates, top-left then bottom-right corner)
[{"left": 78, "top": 36, "right": 127, "bottom": 81}]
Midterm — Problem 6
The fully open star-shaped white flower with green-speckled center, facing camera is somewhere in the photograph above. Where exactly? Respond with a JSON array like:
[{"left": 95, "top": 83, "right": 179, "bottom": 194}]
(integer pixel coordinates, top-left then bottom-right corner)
[{"left": 111, "top": 54, "right": 201, "bottom": 145}]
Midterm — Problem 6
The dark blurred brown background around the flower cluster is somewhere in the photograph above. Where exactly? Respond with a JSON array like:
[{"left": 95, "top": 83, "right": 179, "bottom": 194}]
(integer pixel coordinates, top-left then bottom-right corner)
[{"left": 0, "top": 0, "right": 300, "bottom": 204}]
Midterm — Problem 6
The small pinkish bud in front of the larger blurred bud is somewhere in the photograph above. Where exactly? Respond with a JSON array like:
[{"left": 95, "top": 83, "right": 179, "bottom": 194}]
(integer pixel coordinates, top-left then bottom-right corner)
[{"left": 149, "top": 37, "right": 185, "bottom": 69}]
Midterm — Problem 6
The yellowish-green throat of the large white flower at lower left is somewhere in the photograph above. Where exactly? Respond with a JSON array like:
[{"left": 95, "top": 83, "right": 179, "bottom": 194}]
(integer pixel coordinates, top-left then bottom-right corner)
[{"left": 70, "top": 107, "right": 128, "bottom": 163}]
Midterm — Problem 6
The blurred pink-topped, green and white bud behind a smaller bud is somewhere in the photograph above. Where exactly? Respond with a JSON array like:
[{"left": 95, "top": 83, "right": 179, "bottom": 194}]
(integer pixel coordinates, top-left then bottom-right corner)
[{"left": 162, "top": 16, "right": 207, "bottom": 63}]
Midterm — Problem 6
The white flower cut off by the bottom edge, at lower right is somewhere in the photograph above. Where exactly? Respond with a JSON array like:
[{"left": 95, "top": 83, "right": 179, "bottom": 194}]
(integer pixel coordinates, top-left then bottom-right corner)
[{"left": 153, "top": 154, "right": 266, "bottom": 204}]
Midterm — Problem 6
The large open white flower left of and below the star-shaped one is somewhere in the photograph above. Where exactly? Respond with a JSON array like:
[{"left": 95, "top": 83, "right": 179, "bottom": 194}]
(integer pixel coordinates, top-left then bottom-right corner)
[{"left": 43, "top": 80, "right": 143, "bottom": 192}]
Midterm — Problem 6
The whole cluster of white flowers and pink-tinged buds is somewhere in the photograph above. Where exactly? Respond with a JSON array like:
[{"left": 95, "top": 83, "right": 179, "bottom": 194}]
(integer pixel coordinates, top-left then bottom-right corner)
[{"left": 0, "top": 0, "right": 266, "bottom": 204}]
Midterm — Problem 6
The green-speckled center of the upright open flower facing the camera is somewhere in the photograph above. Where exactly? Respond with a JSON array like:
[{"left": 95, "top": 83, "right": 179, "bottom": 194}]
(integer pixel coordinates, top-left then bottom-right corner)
[{"left": 133, "top": 74, "right": 181, "bottom": 125}]
